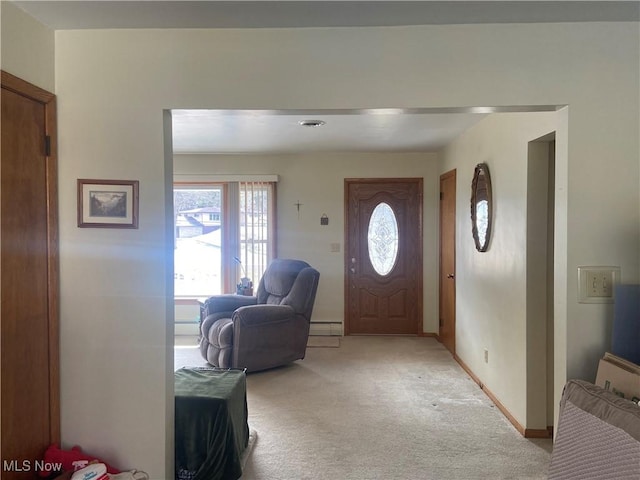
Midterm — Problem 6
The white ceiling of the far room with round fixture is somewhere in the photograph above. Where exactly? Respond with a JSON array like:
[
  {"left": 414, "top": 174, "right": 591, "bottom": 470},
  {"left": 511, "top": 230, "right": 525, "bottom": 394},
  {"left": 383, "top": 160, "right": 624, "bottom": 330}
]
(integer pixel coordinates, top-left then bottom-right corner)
[{"left": 172, "top": 110, "right": 496, "bottom": 153}]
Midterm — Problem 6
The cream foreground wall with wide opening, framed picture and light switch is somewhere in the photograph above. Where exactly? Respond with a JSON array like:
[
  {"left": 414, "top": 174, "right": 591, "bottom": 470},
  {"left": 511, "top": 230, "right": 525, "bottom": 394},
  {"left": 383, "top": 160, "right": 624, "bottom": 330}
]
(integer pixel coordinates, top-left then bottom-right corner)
[{"left": 47, "top": 23, "right": 640, "bottom": 479}]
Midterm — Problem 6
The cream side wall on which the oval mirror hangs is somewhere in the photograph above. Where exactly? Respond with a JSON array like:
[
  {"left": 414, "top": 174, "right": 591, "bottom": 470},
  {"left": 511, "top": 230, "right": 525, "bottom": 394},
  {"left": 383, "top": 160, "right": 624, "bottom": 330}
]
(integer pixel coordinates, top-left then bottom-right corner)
[{"left": 441, "top": 112, "right": 566, "bottom": 429}]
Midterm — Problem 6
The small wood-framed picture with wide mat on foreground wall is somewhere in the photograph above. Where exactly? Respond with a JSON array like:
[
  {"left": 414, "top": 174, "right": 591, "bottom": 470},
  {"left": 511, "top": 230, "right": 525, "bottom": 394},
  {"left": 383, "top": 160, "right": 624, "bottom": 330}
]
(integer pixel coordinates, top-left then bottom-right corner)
[{"left": 78, "top": 179, "right": 138, "bottom": 228}]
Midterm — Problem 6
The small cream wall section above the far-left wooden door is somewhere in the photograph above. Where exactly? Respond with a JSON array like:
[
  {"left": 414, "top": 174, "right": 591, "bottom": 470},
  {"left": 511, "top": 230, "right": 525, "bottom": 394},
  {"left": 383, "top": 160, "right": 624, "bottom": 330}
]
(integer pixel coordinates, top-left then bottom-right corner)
[{"left": 0, "top": 1, "right": 55, "bottom": 93}]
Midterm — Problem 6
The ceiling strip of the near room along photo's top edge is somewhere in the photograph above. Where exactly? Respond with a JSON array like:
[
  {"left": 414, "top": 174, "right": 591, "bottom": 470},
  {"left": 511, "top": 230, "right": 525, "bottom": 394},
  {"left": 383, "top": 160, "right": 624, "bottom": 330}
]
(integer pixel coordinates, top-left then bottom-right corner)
[{"left": 14, "top": 0, "right": 640, "bottom": 30}]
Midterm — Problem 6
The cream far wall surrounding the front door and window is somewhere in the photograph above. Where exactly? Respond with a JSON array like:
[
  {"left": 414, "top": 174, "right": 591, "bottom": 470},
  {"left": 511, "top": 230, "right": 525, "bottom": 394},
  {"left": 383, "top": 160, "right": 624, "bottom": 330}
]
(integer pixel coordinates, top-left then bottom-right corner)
[{"left": 174, "top": 153, "right": 439, "bottom": 333}]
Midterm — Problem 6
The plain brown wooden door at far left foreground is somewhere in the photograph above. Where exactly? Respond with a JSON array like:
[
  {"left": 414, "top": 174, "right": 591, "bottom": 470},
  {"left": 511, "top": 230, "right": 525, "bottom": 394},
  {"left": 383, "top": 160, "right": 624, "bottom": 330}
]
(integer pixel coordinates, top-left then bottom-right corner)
[{"left": 0, "top": 72, "right": 60, "bottom": 480}]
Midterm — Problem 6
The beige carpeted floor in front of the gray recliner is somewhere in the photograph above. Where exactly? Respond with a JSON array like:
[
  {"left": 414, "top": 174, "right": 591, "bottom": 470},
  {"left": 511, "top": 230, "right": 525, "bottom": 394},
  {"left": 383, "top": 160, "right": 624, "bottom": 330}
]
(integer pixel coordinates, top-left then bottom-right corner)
[{"left": 176, "top": 337, "right": 552, "bottom": 480}]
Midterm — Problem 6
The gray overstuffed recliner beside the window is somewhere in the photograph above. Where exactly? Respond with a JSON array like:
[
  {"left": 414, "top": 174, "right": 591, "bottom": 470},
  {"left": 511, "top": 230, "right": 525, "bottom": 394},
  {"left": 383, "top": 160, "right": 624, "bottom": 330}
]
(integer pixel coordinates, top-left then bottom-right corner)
[{"left": 200, "top": 259, "right": 320, "bottom": 372}]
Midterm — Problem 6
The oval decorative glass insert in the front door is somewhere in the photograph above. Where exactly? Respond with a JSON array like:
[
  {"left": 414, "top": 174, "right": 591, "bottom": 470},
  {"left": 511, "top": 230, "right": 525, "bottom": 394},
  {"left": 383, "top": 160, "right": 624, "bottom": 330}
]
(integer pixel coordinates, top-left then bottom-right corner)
[{"left": 367, "top": 202, "right": 398, "bottom": 276}]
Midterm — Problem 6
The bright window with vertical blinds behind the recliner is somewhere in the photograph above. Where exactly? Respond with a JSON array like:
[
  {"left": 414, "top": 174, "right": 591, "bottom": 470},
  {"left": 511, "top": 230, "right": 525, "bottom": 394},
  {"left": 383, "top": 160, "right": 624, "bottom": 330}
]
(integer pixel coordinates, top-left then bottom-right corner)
[{"left": 173, "top": 182, "right": 275, "bottom": 297}]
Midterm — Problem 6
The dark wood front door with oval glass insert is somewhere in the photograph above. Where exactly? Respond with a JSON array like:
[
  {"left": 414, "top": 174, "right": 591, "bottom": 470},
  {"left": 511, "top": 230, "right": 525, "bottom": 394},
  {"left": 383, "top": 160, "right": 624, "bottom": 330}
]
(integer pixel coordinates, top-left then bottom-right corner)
[{"left": 345, "top": 178, "right": 422, "bottom": 335}]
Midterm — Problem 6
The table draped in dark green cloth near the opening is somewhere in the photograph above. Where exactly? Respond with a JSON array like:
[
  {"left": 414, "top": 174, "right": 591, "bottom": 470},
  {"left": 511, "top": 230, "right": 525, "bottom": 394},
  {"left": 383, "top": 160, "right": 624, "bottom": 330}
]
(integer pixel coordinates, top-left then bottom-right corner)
[{"left": 175, "top": 368, "right": 249, "bottom": 480}]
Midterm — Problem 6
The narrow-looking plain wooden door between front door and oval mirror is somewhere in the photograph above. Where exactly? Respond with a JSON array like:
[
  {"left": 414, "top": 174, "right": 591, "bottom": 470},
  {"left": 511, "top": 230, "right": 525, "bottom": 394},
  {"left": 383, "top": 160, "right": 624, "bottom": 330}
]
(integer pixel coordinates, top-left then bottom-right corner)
[{"left": 439, "top": 170, "right": 456, "bottom": 354}]
